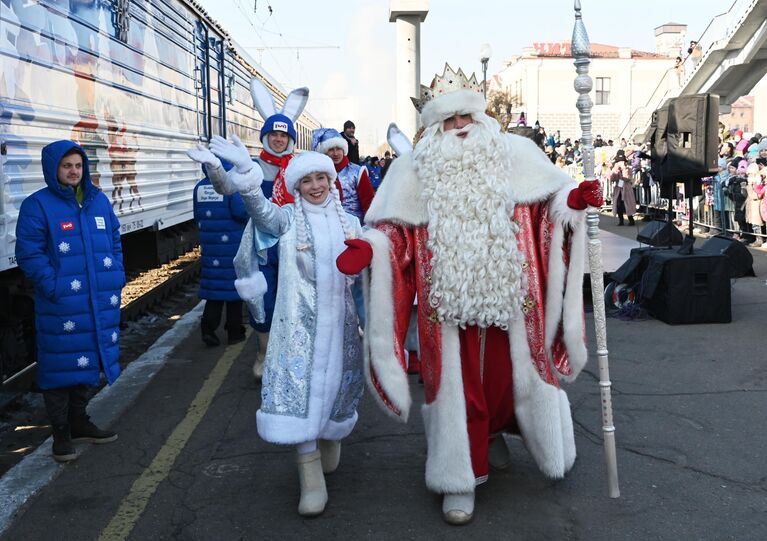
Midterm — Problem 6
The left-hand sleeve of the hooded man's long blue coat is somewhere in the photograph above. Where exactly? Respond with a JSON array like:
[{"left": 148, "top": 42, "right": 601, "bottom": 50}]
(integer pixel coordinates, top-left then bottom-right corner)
[{"left": 16, "top": 198, "right": 56, "bottom": 300}]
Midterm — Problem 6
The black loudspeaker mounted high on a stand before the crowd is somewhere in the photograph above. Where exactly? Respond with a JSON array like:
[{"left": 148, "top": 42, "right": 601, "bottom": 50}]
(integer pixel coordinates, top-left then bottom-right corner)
[{"left": 663, "top": 94, "right": 719, "bottom": 182}]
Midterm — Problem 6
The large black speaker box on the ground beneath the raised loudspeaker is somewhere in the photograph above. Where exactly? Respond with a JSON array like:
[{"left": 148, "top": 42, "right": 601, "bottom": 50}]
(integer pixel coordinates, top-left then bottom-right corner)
[{"left": 642, "top": 250, "right": 732, "bottom": 325}]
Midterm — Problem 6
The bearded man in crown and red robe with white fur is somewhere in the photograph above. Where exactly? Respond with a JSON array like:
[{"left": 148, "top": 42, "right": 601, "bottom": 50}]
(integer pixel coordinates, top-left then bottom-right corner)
[{"left": 332, "top": 65, "right": 602, "bottom": 524}]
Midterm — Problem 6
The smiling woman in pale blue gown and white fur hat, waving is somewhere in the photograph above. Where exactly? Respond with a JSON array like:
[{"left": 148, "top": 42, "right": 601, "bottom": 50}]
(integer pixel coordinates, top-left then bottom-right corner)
[{"left": 204, "top": 144, "right": 364, "bottom": 516}]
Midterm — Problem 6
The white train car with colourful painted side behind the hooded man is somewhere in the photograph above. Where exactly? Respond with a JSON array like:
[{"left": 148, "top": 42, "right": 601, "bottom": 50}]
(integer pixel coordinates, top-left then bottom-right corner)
[{"left": 0, "top": 0, "right": 319, "bottom": 379}]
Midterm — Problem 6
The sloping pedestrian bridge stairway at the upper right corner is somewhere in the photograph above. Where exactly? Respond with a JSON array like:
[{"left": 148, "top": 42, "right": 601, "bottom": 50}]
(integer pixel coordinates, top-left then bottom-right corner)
[{"left": 619, "top": 0, "right": 767, "bottom": 140}]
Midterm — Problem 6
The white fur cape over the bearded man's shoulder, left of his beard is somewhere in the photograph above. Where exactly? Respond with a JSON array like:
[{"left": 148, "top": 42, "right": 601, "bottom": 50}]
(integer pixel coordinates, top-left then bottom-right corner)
[{"left": 365, "top": 153, "right": 429, "bottom": 225}]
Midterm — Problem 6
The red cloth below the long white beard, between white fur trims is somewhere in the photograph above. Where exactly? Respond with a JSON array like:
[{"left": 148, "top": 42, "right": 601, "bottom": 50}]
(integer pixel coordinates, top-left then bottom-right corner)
[{"left": 459, "top": 327, "right": 518, "bottom": 482}]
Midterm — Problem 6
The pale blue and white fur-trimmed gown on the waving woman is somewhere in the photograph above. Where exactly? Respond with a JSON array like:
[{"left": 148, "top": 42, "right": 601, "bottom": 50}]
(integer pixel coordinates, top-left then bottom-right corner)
[{"left": 238, "top": 190, "right": 364, "bottom": 444}]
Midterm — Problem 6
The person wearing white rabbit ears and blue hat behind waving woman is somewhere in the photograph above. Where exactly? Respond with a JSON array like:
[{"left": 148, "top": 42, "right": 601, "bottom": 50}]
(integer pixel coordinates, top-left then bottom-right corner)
[{"left": 187, "top": 77, "right": 309, "bottom": 379}]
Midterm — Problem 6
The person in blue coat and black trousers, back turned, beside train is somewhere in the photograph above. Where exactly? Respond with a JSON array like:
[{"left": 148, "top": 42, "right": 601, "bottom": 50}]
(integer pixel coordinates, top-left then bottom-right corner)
[{"left": 194, "top": 164, "right": 248, "bottom": 346}]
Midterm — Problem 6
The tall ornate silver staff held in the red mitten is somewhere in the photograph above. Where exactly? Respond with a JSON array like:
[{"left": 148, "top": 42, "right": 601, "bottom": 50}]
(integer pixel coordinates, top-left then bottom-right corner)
[{"left": 572, "top": 0, "right": 621, "bottom": 498}]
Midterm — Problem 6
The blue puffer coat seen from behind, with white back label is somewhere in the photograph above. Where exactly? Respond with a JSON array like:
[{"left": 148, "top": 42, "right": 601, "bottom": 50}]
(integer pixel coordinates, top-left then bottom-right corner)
[{"left": 194, "top": 177, "right": 248, "bottom": 301}]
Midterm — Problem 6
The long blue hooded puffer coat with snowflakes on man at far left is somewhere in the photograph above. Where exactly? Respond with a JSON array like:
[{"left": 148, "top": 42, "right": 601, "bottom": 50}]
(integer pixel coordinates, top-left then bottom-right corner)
[{"left": 16, "top": 141, "right": 125, "bottom": 389}]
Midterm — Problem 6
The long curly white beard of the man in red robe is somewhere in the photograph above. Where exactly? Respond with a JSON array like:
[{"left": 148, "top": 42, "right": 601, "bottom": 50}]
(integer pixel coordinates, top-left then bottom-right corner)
[{"left": 413, "top": 115, "right": 527, "bottom": 329}]
